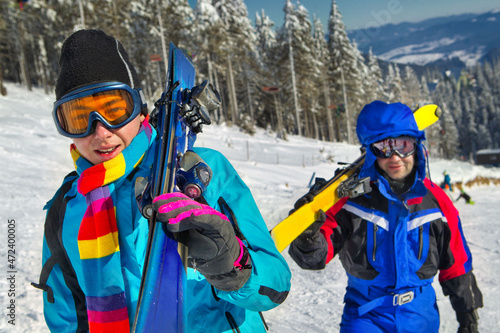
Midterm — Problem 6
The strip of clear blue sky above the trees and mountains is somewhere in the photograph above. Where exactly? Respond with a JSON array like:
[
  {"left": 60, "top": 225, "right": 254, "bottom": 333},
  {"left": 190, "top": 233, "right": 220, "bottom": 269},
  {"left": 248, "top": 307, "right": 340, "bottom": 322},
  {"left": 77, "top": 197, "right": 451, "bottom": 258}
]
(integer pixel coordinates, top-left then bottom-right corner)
[{"left": 188, "top": 0, "right": 500, "bottom": 30}]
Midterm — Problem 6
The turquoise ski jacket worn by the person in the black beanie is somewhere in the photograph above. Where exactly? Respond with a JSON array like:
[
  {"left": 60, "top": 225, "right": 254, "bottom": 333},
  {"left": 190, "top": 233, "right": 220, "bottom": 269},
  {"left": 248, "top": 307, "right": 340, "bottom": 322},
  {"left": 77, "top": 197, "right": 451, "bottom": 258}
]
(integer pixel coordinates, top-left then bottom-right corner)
[{"left": 34, "top": 137, "right": 291, "bottom": 332}]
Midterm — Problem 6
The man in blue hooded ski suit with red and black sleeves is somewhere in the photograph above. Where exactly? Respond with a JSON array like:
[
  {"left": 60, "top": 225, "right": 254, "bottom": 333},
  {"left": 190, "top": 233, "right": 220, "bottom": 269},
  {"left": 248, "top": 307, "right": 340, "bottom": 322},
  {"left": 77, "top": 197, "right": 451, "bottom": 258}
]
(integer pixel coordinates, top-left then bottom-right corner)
[{"left": 289, "top": 101, "right": 483, "bottom": 333}]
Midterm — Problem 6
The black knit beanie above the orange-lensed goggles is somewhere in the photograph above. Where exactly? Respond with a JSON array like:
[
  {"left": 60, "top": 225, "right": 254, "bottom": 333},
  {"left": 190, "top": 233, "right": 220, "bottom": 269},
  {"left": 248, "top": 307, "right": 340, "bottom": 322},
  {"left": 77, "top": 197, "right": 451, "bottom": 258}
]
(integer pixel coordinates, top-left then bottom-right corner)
[{"left": 56, "top": 29, "right": 139, "bottom": 99}]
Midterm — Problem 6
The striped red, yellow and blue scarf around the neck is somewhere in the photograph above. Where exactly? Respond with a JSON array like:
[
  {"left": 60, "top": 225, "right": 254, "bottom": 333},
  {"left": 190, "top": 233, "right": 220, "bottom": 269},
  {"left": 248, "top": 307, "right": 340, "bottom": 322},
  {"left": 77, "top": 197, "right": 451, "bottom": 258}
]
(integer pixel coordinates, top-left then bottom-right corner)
[{"left": 71, "top": 119, "right": 152, "bottom": 332}]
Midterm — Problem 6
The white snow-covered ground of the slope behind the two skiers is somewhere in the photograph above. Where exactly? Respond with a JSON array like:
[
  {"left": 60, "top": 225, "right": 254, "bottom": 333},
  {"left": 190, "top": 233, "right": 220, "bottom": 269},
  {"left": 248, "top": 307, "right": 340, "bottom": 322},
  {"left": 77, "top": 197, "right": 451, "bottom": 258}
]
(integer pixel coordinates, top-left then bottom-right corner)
[{"left": 0, "top": 84, "right": 500, "bottom": 333}]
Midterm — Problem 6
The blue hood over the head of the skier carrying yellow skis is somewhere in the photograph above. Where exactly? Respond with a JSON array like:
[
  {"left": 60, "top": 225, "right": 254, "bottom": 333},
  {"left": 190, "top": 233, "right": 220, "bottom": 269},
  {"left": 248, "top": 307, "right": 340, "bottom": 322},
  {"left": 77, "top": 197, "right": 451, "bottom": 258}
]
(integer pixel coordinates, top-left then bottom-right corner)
[{"left": 356, "top": 101, "right": 426, "bottom": 195}]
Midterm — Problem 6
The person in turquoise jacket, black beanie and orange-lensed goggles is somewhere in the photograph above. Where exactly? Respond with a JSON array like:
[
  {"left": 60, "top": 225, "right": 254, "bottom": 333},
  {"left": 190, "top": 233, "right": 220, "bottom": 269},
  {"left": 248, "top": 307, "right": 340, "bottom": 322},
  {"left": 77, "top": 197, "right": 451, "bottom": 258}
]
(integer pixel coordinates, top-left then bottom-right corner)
[{"left": 34, "top": 30, "right": 291, "bottom": 332}]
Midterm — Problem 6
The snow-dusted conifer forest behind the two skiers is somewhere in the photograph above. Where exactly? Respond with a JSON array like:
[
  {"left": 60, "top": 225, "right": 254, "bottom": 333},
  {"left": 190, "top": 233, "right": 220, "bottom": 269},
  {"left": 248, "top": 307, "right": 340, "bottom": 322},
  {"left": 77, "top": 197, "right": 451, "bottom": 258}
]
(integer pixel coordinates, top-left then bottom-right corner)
[{"left": 0, "top": 0, "right": 500, "bottom": 159}]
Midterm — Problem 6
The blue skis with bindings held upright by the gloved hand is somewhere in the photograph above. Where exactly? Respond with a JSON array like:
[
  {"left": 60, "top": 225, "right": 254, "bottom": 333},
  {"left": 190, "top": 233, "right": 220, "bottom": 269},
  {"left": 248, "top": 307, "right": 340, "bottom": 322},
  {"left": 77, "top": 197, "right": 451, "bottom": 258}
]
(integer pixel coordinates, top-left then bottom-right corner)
[{"left": 132, "top": 43, "right": 220, "bottom": 332}]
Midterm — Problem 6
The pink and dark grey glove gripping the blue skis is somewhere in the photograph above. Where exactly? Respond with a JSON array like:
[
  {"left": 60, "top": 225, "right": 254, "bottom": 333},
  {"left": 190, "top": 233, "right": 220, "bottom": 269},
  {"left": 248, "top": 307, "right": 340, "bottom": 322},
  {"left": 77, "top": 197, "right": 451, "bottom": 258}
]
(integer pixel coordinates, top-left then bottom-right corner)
[{"left": 153, "top": 192, "right": 251, "bottom": 291}]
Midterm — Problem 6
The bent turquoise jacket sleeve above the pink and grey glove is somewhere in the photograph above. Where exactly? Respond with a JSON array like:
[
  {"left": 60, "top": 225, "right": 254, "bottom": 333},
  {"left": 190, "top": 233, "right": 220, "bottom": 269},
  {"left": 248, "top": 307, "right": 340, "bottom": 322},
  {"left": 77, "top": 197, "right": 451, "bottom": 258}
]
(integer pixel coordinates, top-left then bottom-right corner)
[{"left": 195, "top": 148, "right": 291, "bottom": 311}]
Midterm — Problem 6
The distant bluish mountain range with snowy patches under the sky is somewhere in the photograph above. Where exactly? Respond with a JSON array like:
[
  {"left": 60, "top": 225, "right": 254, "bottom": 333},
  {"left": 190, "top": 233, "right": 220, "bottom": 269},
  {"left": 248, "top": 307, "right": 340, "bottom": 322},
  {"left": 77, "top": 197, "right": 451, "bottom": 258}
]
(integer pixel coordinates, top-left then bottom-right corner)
[{"left": 347, "top": 7, "right": 500, "bottom": 70}]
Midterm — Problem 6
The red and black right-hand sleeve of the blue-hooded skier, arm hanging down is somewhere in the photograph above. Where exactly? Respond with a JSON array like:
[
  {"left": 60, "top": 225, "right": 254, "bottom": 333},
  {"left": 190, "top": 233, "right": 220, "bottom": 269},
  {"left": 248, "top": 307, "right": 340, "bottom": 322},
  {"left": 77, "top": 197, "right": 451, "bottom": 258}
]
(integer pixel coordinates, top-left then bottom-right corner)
[{"left": 425, "top": 179, "right": 483, "bottom": 313}]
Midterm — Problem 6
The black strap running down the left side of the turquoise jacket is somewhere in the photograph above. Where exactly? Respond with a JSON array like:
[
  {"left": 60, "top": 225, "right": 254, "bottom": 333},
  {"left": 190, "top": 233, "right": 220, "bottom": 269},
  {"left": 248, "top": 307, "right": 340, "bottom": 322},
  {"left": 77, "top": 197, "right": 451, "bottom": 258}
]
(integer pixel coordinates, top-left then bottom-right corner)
[{"left": 31, "top": 171, "right": 88, "bottom": 332}]
